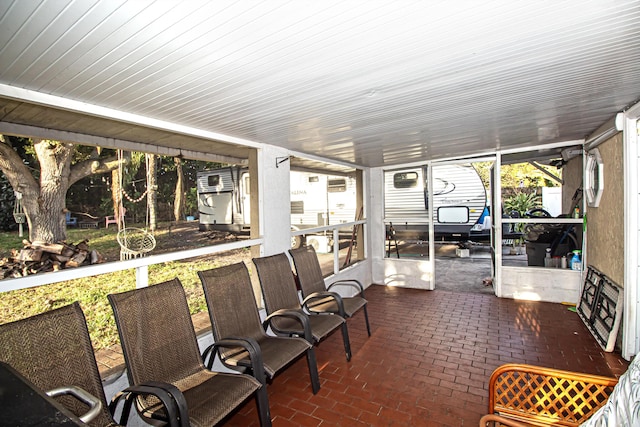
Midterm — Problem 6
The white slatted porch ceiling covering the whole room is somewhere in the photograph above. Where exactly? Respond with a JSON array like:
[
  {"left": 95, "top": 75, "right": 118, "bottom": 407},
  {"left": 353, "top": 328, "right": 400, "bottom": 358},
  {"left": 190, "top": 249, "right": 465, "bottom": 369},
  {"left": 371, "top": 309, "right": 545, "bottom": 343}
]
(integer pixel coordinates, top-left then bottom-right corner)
[{"left": 0, "top": 0, "right": 640, "bottom": 166}]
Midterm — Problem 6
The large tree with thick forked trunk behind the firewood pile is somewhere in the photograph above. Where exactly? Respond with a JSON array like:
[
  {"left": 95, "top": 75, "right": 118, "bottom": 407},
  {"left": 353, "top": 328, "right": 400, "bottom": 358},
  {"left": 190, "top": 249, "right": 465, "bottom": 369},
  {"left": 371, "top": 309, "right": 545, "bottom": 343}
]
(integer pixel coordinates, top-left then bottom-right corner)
[{"left": 0, "top": 135, "right": 119, "bottom": 243}]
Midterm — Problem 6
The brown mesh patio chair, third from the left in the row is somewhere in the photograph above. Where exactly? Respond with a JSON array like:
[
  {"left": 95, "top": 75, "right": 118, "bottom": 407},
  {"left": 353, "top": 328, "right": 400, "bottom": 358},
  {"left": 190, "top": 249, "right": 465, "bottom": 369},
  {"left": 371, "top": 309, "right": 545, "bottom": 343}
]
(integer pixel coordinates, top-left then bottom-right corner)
[{"left": 198, "top": 262, "right": 320, "bottom": 394}]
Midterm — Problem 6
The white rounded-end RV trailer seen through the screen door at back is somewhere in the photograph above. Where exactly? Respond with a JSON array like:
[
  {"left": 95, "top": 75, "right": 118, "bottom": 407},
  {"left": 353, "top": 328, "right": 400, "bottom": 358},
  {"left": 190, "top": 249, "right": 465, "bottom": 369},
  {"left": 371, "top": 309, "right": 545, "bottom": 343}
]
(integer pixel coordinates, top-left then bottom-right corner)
[{"left": 384, "top": 164, "right": 488, "bottom": 242}]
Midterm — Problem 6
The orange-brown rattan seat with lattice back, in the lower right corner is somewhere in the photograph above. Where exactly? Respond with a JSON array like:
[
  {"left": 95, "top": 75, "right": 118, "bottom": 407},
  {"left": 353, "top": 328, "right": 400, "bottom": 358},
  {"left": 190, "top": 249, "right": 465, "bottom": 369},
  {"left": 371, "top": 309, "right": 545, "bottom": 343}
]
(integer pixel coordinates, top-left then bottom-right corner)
[{"left": 480, "top": 364, "right": 618, "bottom": 427}]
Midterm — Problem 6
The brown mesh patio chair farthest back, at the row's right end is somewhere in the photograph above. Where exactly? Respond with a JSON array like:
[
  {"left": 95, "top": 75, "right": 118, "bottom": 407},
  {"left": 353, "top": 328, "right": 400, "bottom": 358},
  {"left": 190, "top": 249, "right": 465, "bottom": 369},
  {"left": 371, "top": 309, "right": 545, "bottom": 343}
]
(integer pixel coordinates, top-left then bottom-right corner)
[{"left": 289, "top": 246, "right": 371, "bottom": 336}]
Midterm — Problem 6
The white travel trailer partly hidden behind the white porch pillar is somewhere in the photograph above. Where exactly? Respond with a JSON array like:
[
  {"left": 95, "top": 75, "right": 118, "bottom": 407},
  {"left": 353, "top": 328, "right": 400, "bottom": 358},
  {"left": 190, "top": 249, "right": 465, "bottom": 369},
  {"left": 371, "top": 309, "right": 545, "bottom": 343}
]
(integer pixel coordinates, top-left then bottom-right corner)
[{"left": 197, "top": 166, "right": 356, "bottom": 252}]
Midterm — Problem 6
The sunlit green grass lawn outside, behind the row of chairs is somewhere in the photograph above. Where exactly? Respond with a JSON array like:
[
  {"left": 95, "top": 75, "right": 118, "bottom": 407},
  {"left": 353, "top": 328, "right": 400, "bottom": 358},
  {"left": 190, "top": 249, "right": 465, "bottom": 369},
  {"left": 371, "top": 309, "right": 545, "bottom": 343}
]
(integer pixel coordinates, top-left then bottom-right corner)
[{"left": 0, "top": 229, "right": 250, "bottom": 349}]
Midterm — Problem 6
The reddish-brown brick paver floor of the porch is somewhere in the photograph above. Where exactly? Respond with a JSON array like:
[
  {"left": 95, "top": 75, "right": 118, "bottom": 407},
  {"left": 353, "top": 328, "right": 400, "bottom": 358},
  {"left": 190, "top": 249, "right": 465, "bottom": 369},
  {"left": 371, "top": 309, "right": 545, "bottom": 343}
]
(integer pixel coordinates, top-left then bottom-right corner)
[{"left": 97, "top": 285, "right": 627, "bottom": 427}]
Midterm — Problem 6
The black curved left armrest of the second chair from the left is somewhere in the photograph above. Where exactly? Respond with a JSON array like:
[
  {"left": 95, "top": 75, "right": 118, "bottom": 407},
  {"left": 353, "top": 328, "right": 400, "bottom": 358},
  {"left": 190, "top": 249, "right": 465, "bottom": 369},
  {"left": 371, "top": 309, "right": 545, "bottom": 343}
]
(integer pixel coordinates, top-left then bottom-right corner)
[{"left": 109, "top": 381, "right": 189, "bottom": 427}]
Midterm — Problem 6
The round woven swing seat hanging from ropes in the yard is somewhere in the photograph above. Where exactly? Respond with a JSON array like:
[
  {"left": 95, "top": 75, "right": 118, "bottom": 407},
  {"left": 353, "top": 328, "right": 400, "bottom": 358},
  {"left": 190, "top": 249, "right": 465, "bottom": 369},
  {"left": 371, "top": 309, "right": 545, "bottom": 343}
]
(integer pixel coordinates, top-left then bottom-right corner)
[{"left": 116, "top": 150, "right": 156, "bottom": 261}]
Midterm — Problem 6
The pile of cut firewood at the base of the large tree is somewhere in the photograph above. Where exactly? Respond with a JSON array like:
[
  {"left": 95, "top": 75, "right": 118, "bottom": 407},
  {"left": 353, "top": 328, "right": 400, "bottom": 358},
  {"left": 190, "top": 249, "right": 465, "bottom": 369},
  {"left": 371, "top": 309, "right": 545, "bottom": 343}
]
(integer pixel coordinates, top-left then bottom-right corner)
[{"left": 0, "top": 240, "right": 104, "bottom": 279}]
